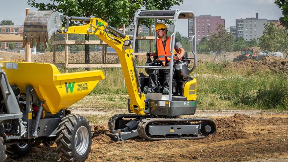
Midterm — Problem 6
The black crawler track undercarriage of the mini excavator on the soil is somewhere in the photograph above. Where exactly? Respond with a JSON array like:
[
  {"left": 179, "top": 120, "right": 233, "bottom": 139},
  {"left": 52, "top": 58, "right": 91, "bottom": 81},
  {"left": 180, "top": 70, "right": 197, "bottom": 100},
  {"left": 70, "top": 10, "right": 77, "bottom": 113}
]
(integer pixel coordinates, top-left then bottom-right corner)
[{"left": 108, "top": 114, "right": 216, "bottom": 141}]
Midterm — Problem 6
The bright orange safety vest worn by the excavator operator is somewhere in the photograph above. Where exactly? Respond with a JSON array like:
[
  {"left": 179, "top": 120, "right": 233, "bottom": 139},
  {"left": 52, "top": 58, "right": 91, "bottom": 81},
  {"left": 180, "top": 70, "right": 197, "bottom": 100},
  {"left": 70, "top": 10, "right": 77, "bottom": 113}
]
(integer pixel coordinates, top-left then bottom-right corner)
[{"left": 157, "top": 37, "right": 180, "bottom": 66}]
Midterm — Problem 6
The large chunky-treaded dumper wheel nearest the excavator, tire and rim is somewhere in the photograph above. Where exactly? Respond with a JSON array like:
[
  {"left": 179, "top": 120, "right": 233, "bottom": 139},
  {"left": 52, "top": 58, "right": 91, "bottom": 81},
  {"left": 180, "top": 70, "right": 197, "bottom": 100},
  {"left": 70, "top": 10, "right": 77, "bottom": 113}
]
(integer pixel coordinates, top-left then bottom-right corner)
[{"left": 55, "top": 114, "right": 92, "bottom": 161}]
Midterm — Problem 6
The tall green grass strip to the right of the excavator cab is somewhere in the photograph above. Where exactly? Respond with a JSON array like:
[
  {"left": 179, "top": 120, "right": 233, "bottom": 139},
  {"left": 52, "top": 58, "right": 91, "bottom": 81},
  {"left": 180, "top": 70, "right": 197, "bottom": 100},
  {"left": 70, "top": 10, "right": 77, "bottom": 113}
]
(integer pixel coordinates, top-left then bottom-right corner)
[{"left": 197, "top": 63, "right": 288, "bottom": 110}]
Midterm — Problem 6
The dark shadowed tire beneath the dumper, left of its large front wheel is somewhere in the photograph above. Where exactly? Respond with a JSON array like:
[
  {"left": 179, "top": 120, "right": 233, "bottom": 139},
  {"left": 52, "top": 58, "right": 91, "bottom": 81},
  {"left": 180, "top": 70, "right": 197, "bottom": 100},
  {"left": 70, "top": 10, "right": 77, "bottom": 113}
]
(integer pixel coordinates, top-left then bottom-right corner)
[{"left": 6, "top": 142, "right": 31, "bottom": 159}]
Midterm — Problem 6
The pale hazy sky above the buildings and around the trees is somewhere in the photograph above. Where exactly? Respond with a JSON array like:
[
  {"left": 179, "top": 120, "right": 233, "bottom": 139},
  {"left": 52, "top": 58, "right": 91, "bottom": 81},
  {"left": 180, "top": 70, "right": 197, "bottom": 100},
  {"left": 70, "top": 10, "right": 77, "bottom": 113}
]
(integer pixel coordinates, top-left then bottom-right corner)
[{"left": 0, "top": 0, "right": 282, "bottom": 36}]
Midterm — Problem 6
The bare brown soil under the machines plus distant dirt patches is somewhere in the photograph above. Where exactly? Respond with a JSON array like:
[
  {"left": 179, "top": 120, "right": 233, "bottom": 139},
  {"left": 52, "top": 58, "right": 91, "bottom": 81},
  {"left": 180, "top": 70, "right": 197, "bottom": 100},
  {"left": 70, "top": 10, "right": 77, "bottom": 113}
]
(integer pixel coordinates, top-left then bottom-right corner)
[{"left": 0, "top": 52, "right": 288, "bottom": 162}]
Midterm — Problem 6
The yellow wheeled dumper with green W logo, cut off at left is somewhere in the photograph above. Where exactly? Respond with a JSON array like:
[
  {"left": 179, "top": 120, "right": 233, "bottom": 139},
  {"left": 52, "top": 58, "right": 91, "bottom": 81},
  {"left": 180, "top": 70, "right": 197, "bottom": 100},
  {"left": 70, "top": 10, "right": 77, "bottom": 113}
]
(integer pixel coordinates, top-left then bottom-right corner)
[{"left": 0, "top": 62, "right": 104, "bottom": 161}]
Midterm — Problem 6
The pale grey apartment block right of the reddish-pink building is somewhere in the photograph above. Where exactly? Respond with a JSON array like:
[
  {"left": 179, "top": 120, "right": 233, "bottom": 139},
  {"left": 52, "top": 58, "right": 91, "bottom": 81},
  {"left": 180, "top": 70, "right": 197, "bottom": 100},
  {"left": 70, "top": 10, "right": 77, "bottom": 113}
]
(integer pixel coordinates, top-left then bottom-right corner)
[{"left": 236, "top": 13, "right": 268, "bottom": 41}]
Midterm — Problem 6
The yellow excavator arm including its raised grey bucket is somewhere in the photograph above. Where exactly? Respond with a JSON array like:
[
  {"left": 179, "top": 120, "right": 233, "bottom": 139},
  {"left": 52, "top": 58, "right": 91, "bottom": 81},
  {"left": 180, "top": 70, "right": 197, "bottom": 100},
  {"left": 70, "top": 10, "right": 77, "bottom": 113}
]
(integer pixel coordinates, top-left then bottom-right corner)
[{"left": 23, "top": 11, "right": 146, "bottom": 115}]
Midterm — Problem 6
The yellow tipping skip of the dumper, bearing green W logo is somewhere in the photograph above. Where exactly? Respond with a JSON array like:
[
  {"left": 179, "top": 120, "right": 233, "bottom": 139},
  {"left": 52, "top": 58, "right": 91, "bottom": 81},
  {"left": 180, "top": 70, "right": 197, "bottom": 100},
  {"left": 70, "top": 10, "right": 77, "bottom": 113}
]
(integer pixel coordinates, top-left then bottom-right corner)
[{"left": 0, "top": 62, "right": 105, "bottom": 114}]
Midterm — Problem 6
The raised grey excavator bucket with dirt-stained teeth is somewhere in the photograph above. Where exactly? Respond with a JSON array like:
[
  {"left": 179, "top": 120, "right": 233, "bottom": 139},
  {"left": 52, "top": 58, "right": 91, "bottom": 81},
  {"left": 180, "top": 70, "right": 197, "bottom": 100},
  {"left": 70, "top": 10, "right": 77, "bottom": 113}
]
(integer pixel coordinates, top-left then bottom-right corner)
[{"left": 23, "top": 11, "right": 62, "bottom": 48}]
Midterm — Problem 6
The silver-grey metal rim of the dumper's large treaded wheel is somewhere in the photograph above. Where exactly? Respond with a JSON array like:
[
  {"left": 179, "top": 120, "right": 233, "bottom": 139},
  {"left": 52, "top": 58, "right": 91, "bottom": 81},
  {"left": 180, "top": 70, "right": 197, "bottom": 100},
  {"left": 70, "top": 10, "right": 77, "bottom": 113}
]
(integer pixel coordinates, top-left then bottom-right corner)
[{"left": 74, "top": 126, "right": 89, "bottom": 155}]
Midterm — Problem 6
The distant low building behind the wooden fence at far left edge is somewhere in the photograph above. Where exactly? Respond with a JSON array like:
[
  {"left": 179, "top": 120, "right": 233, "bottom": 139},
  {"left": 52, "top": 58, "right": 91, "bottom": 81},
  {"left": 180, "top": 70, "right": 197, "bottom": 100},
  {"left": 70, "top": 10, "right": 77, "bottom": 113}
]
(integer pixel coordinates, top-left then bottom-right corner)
[{"left": 0, "top": 25, "right": 23, "bottom": 49}]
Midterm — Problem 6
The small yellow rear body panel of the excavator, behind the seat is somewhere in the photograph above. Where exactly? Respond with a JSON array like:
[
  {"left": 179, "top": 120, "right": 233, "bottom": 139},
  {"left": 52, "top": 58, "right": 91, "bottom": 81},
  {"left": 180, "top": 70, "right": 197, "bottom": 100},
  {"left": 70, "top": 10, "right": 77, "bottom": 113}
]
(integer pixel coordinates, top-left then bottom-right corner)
[{"left": 184, "top": 78, "right": 197, "bottom": 101}]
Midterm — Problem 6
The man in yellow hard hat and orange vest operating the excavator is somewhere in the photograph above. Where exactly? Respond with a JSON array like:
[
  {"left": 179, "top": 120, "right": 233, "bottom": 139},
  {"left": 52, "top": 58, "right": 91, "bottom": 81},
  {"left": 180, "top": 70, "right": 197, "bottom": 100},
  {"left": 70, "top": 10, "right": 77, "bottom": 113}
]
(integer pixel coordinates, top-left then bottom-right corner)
[{"left": 147, "top": 23, "right": 185, "bottom": 94}]
